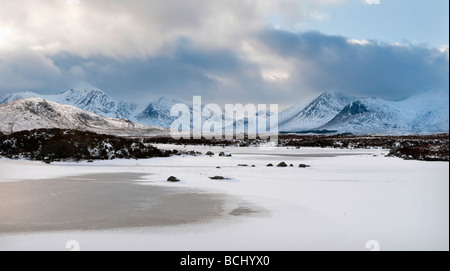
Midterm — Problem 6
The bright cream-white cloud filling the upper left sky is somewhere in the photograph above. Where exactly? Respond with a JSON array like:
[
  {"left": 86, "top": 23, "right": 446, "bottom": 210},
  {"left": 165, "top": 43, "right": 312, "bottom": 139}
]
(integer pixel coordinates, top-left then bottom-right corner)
[{"left": 0, "top": 0, "right": 343, "bottom": 58}]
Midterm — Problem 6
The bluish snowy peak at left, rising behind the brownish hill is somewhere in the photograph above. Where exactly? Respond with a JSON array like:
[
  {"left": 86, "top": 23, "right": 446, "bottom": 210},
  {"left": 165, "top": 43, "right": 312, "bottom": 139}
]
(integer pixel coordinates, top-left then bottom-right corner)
[{"left": 0, "top": 85, "right": 136, "bottom": 122}]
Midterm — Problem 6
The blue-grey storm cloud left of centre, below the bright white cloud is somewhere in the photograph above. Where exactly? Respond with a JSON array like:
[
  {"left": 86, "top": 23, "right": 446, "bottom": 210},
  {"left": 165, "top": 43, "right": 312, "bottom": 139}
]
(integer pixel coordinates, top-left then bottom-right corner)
[{"left": 47, "top": 38, "right": 260, "bottom": 103}]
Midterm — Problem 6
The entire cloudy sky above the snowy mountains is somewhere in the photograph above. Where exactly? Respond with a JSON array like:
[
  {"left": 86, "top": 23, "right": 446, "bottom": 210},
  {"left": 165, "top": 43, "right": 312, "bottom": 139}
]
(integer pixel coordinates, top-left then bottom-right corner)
[{"left": 0, "top": 0, "right": 449, "bottom": 104}]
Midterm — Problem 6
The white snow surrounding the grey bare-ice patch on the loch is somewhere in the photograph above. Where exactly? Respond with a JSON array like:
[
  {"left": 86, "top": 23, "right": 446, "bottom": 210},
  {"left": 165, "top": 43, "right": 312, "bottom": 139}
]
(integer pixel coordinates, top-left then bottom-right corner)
[{"left": 0, "top": 148, "right": 449, "bottom": 250}]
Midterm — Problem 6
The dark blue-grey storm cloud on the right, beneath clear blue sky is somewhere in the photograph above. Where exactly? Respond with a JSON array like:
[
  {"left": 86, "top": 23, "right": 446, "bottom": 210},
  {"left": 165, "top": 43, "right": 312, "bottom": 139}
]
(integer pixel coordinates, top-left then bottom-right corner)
[{"left": 260, "top": 30, "right": 449, "bottom": 99}]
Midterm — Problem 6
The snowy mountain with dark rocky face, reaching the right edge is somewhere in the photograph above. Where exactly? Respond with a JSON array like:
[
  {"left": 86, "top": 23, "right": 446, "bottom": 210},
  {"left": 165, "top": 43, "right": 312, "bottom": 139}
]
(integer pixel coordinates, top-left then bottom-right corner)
[{"left": 319, "top": 91, "right": 449, "bottom": 134}]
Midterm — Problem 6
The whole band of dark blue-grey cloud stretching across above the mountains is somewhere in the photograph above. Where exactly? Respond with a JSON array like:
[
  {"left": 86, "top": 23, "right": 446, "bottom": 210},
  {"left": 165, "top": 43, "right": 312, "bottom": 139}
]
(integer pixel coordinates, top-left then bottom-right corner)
[{"left": 0, "top": 30, "right": 449, "bottom": 104}]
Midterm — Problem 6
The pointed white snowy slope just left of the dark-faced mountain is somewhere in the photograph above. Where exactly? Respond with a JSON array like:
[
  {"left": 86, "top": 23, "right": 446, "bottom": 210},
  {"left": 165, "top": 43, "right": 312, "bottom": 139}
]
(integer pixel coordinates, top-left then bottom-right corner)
[{"left": 279, "top": 92, "right": 354, "bottom": 132}]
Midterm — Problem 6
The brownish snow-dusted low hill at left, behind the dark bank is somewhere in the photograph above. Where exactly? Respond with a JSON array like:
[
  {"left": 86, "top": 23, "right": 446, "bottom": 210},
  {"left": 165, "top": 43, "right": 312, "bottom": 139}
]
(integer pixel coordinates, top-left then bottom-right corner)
[{"left": 0, "top": 98, "right": 166, "bottom": 135}]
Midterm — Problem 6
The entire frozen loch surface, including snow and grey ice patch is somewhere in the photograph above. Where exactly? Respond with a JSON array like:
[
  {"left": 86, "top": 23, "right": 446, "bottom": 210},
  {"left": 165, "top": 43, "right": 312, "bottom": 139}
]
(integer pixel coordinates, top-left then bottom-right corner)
[{"left": 0, "top": 148, "right": 449, "bottom": 250}]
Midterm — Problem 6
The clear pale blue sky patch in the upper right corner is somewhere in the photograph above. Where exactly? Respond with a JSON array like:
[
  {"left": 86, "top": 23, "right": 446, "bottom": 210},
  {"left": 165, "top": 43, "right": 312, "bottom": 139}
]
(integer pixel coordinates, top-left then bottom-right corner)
[{"left": 269, "top": 0, "right": 449, "bottom": 48}]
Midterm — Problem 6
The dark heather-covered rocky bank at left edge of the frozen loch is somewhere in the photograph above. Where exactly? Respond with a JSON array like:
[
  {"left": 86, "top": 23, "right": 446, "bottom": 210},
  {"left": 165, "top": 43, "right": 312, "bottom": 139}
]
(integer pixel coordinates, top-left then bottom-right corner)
[{"left": 0, "top": 129, "right": 173, "bottom": 162}]
